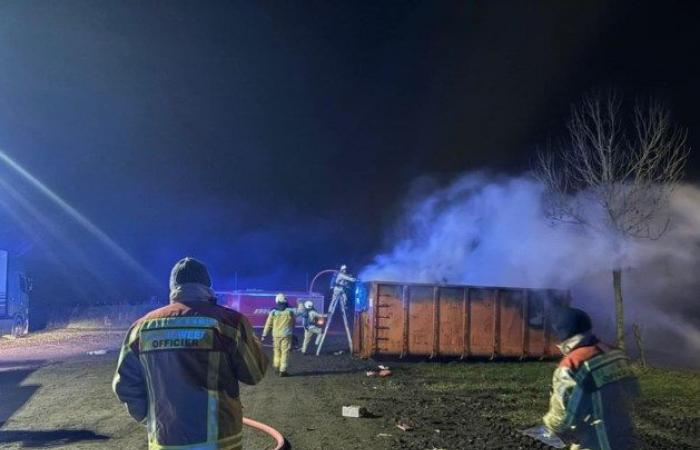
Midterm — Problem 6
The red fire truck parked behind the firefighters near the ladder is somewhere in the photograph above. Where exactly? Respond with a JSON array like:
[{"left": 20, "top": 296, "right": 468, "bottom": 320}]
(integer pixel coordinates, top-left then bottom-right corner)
[{"left": 216, "top": 289, "right": 325, "bottom": 328}]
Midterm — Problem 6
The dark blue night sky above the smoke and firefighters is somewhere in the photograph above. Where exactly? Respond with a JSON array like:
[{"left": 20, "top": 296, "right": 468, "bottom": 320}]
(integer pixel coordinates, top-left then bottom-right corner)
[{"left": 0, "top": 0, "right": 700, "bottom": 302}]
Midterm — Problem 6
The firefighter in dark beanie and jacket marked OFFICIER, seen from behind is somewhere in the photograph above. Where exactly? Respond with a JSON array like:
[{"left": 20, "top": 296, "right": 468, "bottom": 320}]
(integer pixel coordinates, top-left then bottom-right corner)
[{"left": 112, "top": 258, "right": 268, "bottom": 450}]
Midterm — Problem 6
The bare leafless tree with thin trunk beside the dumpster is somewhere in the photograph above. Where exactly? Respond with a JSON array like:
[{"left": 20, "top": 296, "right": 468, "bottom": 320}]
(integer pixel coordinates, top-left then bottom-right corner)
[{"left": 535, "top": 92, "right": 689, "bottom": 348}]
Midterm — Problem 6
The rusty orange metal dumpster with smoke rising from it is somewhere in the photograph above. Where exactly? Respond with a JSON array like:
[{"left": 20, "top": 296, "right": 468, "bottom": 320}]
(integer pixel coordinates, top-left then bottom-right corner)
[{"left": 353, "top": 281, "right": 570, "bottom": 358}]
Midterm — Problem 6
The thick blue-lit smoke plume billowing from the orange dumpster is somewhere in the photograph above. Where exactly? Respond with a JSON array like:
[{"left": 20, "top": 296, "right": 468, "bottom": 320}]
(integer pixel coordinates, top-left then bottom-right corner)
[{"left": 360, "top": 172, "right": 700, "bottom": 365}]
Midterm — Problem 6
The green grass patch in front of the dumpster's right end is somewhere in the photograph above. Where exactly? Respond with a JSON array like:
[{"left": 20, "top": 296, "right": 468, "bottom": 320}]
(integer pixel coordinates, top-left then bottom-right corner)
[{"left": 396, "top": 362, "right": 700, "bottom": 448}]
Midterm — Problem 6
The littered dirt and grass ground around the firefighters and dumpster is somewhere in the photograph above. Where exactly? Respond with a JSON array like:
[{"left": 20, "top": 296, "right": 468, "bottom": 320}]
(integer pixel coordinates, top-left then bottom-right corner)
[{"left": 0, "top": 333, "right": 700, "bottom": 450}]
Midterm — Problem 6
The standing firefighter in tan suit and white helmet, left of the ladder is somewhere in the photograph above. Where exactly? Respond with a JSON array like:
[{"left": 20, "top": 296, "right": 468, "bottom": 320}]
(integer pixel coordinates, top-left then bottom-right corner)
[{"left": 262, "top": 293, "right": 296, "bottom": 377}]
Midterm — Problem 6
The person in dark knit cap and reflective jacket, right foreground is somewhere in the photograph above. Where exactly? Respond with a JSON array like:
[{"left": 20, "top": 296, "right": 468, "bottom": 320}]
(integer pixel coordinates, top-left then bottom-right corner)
[{"left": 543, "top": 308, "right": 639, "bottom": 450}]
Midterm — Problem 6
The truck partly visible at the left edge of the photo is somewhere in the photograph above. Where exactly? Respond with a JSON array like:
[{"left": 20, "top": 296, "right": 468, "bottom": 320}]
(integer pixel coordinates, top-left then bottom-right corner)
[{"left": 0, "top": 250, "right": 32, "bottom": 337}]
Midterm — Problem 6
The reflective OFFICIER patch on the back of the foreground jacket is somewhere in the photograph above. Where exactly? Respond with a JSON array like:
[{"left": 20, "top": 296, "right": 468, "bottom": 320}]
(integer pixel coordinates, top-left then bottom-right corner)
[{"left": 139, "top": 328, "right": 214, "bottom": 352}]
